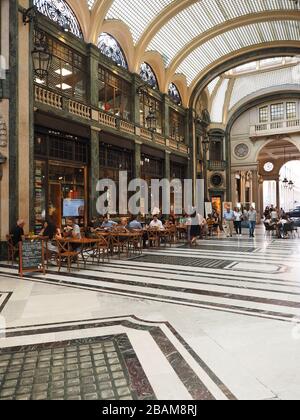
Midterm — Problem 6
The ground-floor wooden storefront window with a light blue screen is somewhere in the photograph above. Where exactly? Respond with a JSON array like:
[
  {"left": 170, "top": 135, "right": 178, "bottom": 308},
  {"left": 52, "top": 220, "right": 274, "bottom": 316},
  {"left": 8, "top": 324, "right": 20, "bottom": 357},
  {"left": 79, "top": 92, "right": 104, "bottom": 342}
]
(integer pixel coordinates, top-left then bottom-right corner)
[{"left": 34, "top": 129, "right": 88, "bottom": 233}]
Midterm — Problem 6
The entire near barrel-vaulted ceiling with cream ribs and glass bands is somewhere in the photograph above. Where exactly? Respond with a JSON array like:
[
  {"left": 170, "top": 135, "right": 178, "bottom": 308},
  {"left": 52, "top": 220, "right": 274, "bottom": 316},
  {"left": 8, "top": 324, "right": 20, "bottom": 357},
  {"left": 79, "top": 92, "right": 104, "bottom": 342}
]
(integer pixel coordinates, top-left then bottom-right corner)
[{"left": 41, "top": 0, "right": 300, "bottom": 104}]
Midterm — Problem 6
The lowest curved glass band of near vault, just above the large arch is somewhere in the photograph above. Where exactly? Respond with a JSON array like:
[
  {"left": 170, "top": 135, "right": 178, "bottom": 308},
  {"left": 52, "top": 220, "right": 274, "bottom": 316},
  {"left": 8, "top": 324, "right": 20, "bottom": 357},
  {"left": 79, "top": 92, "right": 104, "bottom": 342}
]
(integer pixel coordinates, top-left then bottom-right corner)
[{"left": 176, "top": 21, "right": 300, "bottom": 84}]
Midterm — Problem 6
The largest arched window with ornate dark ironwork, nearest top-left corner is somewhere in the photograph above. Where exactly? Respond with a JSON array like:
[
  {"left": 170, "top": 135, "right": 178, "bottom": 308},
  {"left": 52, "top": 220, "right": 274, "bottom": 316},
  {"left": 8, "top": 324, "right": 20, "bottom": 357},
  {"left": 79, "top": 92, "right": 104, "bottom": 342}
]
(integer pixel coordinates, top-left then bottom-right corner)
[{"left": 33, "top": 0, "right": 83, "bottom": 38}]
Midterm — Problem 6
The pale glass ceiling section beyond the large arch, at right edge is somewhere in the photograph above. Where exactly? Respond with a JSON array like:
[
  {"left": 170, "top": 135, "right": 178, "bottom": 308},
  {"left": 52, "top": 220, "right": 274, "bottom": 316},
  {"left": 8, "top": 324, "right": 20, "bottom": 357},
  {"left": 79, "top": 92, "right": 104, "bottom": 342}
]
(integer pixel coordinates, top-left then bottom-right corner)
[{"left": 229, "top": 64, "right": 300, "bottom": 109}]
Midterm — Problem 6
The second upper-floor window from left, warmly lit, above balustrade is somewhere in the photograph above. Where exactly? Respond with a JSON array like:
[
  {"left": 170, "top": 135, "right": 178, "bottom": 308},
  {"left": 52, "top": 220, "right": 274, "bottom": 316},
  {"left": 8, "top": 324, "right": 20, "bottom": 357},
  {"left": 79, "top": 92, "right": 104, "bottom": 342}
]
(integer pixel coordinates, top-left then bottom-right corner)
[{"left": 98, "top": 66, "right": 132, "bottom": 121}]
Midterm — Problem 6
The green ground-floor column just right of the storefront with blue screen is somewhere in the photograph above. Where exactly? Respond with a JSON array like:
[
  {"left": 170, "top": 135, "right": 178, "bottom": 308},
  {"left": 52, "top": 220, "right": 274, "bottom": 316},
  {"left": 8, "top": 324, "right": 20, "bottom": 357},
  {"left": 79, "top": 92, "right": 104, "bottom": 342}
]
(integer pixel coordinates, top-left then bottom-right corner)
[{"left": 89, "top": 128, "right": 100, "bottom": 220}]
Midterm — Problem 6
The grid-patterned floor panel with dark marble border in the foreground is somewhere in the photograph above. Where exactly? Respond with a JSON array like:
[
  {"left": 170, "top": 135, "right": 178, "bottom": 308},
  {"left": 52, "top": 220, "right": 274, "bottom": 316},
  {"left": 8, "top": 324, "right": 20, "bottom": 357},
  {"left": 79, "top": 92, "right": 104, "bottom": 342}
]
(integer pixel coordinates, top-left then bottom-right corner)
[{"left": 0, "top": 334, "right": 156, "bottom": 400}]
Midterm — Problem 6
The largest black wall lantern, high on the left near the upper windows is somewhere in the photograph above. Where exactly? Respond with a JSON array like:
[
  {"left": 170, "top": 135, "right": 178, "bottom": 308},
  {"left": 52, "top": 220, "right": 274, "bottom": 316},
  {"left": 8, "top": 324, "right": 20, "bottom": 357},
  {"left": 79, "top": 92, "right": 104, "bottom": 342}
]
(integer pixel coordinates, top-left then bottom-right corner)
[{"left": 31, "top": 31, "right": 52, "bottom": 81}]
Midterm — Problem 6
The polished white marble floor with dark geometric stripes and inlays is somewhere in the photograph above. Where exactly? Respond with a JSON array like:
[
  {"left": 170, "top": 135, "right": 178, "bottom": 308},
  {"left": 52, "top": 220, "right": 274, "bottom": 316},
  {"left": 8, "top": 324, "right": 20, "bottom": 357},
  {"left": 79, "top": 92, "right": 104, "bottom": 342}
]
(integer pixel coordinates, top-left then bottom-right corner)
[{"left": 0, "top": 230, "right": 300, "bottom": 400}]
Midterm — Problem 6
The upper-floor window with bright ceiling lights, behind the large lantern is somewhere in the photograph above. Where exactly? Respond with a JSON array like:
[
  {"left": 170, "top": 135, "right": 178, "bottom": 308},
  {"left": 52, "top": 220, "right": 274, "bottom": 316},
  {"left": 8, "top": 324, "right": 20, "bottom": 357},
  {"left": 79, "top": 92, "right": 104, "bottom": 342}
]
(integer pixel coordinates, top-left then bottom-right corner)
[{"left": 35, "top": 31, "right": 87, "bottom": 102}]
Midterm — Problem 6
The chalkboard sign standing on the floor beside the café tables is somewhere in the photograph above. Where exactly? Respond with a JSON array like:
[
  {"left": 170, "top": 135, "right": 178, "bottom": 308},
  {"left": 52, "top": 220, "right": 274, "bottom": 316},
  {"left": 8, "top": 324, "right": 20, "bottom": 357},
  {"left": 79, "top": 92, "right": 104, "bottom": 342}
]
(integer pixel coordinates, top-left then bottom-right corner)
[{"left": 19, "top": 239, "right": 45, "bottom": 277}]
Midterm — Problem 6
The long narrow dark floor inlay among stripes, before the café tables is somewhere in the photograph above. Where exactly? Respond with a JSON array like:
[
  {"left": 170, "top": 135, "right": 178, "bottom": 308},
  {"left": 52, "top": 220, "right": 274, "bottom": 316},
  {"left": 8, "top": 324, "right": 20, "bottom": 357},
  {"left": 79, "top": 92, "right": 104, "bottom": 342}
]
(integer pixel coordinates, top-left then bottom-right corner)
[{"left": 136, "top": 255, "right": 234, "bottom": 269}]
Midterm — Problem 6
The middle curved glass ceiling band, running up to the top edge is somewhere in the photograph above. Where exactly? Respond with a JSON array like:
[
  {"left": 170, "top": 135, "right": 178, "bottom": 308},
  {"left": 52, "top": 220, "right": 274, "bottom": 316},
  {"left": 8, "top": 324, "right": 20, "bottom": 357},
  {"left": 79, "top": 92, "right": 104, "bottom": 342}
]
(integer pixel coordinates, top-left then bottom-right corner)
[{"left": 148, "top": 0, "right": 295, "bottom": 65}]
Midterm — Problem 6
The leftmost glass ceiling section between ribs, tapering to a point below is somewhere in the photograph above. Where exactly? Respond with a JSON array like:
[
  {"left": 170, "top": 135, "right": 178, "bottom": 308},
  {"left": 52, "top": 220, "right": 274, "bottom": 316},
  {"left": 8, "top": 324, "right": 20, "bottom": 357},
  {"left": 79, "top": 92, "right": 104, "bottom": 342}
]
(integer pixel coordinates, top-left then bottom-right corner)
[{"left": 106, "top": 0, "right": 173, "bottom": 43}]
